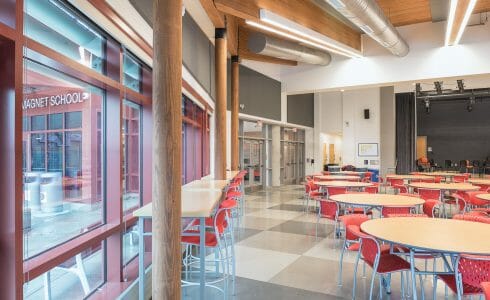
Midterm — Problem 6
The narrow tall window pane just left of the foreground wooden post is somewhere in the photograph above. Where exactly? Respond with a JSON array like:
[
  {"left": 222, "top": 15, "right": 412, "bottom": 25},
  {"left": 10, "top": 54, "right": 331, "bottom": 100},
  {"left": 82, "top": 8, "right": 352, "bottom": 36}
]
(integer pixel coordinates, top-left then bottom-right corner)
[{"left": 122, "top": 100, "right": 141, "bottom": 212}]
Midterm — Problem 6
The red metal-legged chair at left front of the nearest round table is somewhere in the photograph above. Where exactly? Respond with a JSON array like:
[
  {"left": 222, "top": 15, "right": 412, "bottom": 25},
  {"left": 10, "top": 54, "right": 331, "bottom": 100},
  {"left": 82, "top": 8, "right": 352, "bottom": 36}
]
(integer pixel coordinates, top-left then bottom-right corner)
[{"left": 349, "top": 225, "right": 422, "bottom": 300}]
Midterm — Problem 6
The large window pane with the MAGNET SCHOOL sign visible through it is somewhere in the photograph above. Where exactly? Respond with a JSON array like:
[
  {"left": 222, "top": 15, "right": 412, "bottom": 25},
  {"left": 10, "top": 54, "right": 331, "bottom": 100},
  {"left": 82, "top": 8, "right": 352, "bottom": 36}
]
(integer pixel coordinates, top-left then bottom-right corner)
[{"left": 22, "top": 59, "right": 105, "bottom": 259}]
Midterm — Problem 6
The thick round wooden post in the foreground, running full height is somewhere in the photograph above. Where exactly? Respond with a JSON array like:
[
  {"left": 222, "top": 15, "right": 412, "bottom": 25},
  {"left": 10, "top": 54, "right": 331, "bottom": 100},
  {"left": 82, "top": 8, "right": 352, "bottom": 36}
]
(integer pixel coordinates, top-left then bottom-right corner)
[{"left": 151, "top": 0, "right": 182, "bottom": 299}]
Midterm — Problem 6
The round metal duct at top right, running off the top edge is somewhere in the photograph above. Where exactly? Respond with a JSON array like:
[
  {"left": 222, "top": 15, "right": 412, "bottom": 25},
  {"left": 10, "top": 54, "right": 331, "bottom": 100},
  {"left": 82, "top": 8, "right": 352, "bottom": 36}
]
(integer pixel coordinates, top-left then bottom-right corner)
[{"left": 324, "top": 0, "right": 409, "bottom": 56}]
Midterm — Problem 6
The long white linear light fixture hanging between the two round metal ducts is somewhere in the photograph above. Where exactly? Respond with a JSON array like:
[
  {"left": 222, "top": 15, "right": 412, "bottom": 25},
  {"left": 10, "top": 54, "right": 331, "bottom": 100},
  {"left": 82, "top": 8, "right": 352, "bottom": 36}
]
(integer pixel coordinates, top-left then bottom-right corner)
[{"left": 246, "top": 9, "right": 362, "bottom": 58}]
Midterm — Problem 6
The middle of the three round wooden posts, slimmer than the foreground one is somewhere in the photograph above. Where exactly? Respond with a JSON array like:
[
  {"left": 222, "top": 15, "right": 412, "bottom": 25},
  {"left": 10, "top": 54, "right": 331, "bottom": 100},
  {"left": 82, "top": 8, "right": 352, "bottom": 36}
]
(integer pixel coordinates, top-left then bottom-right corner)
[{"left": 214, "top": 28, "right": 227, "bottom": 180}]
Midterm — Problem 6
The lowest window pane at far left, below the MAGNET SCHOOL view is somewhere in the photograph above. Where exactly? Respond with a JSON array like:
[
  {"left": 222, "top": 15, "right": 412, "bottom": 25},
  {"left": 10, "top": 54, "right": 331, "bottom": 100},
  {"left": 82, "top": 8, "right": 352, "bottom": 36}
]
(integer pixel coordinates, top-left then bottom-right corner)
[{"left": 24, "top": 244, "right": 105, "bottom": 300}]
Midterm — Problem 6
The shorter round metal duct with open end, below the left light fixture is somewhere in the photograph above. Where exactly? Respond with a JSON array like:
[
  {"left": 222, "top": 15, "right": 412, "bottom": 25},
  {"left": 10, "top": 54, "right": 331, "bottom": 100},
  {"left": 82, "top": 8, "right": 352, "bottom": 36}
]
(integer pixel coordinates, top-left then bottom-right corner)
[{"left": 248, "top": 33, "right": 332, "bottom": 66}]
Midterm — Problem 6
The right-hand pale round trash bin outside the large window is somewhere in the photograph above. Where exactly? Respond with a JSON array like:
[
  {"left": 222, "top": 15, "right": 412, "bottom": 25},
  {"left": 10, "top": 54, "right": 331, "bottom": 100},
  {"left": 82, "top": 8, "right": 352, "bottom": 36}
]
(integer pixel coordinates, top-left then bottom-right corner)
[{"left": 41, "top": 172, "right": 63, "bottom": 213}]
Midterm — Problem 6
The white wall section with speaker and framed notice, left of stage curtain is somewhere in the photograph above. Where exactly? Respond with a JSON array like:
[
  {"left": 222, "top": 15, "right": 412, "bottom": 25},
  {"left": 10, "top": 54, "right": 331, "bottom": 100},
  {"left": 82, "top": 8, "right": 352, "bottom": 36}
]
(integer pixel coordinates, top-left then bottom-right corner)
[{"left": 342, "top": 88, "right": 380, "bottom": 168}]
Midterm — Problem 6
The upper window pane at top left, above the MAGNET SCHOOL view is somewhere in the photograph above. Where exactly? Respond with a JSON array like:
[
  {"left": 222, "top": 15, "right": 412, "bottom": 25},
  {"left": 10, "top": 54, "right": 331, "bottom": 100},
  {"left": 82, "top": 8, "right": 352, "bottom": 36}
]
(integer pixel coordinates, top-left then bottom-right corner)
[{"left": 24, "top": 0, "right": 105, "bottom": 73}]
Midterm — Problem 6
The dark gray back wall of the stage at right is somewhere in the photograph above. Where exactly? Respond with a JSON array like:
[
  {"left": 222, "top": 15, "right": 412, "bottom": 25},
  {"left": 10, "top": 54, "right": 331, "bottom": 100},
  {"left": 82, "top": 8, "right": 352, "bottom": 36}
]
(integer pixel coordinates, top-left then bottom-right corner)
[{"left": 417, "top": 100, "right": 490, "bottom": 166}]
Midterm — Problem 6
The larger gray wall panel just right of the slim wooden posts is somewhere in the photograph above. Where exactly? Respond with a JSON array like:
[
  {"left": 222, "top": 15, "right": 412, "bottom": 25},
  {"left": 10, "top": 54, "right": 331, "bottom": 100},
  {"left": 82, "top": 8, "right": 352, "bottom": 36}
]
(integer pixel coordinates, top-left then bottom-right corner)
[{"left": 227, "top": 64, "right": 281, "bottom": 121}]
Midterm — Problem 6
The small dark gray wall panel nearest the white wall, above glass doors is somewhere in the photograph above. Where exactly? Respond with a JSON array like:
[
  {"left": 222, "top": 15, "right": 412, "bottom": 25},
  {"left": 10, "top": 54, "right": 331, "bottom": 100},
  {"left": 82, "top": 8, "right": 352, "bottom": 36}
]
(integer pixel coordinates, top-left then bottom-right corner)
[{"left": 288, "top": 93, "right": 315, "bottom": 127}]
